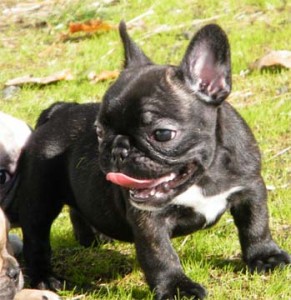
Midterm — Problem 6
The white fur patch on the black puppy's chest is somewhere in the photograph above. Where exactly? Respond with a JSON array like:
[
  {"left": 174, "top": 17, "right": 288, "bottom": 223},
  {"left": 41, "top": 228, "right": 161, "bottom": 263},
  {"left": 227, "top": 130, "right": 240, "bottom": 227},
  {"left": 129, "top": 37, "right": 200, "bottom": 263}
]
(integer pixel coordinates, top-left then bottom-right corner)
[{"left": 172, "top": 185, "right": 243, "bottom": 225}]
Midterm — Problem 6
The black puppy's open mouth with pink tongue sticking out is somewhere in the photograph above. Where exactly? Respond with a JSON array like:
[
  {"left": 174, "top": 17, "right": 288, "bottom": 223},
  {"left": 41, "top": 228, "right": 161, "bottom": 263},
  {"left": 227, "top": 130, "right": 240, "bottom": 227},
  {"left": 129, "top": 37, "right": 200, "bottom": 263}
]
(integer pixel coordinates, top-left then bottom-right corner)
[{"left": 106, "top": 163, "right": 197, "bottom": 204}]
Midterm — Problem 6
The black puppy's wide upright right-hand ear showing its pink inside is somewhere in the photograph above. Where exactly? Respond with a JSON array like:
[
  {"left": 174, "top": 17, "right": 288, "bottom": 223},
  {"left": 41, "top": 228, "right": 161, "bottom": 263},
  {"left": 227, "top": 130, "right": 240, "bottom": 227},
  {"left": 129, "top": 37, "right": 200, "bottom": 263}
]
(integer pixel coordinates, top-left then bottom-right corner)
[{"left": 180, "top": 24, "right": 231, "bottom": 104}]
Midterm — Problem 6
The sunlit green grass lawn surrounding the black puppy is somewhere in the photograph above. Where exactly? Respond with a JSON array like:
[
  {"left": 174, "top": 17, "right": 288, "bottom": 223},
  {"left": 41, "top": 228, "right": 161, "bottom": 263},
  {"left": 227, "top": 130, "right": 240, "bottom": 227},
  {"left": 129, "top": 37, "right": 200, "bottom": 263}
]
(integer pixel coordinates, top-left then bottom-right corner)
[{"left": 0, "top": 0, "right": 291, "bottom": 300}]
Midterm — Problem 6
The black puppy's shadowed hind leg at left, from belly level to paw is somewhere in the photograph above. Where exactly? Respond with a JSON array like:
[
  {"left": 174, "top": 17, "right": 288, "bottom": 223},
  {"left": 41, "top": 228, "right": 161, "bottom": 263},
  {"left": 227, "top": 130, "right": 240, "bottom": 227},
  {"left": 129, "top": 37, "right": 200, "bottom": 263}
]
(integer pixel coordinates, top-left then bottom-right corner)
[{"left": 19, "top": 188, "right": 62, "bottom": 290}]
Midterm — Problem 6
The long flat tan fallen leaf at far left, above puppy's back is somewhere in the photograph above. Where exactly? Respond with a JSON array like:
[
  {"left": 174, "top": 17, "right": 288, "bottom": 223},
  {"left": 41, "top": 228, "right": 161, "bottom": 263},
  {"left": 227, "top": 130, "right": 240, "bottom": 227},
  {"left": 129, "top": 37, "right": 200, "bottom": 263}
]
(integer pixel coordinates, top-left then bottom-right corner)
[{"left": 5, "top": 70, "right": 73, "bottom": 86}]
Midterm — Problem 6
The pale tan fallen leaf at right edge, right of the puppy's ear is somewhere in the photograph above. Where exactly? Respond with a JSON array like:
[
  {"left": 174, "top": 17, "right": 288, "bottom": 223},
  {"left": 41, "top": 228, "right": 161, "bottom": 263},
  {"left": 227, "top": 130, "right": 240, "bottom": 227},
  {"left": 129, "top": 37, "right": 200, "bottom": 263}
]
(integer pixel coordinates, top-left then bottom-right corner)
[{"left": 250, "top": 50, "right": 291, "bottom": 71}]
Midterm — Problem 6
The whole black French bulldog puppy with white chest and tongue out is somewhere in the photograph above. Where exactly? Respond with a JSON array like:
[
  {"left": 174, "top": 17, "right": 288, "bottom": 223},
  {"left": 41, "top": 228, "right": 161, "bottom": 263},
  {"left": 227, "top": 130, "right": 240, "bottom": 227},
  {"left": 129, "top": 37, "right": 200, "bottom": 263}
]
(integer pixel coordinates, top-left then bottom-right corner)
[{"left": 8, "top": 22, "right": 290, "bottom": 299}]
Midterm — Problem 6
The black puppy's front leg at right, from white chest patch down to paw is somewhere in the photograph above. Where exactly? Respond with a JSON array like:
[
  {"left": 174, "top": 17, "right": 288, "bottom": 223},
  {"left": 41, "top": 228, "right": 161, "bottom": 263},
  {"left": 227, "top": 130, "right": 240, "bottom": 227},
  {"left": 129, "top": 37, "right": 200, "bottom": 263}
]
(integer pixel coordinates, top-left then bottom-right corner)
[{"left": 231, "top": 178, "right": 291, "bottom": 272}]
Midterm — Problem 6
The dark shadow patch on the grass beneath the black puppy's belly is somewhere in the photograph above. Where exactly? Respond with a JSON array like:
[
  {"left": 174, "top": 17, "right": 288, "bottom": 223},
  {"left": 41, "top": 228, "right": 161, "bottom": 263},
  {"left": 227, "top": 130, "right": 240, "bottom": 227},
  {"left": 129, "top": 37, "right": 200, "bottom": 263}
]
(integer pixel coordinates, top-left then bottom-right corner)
[{"left": 52, "top": 246, "right": 134, "bottom": 292}]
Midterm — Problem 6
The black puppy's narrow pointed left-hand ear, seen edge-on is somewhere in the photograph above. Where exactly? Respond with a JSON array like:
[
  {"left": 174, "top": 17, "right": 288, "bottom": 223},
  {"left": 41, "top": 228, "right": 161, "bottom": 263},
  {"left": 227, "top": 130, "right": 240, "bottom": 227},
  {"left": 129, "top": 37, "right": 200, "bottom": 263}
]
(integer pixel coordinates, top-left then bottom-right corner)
[{"left": 119, "top": 21, "right": 153, "bottom": 68}]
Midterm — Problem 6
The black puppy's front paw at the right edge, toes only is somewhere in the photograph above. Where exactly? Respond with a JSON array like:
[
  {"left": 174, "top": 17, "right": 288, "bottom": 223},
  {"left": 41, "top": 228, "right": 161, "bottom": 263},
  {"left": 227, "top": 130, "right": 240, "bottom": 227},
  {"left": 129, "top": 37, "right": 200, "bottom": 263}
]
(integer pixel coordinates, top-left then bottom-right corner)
[{"left": 247, "top": 250, "right": 291, "bottom": 273}]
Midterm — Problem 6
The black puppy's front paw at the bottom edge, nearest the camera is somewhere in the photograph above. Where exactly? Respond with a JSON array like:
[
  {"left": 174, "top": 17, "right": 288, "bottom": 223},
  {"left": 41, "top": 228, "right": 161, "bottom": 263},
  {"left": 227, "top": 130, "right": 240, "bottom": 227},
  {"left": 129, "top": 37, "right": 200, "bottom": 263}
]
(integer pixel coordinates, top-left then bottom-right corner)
[{"left": 155, "top": 275, "right": 207, "bottom": 300}]
